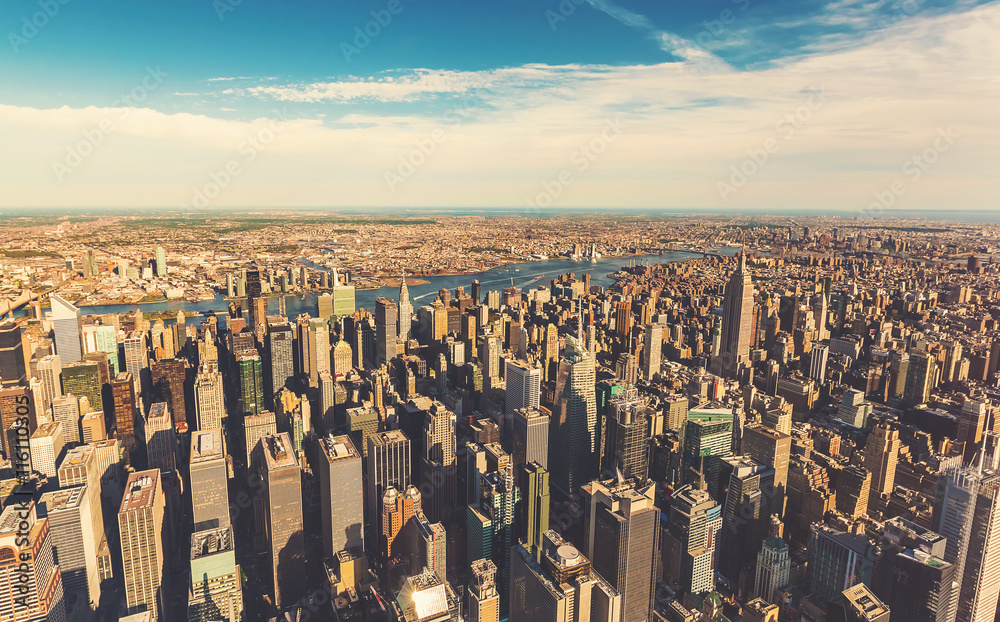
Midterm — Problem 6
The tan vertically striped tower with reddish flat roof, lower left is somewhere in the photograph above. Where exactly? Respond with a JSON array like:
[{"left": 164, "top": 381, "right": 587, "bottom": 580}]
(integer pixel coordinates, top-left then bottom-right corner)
[{"left": 118, "top": 469, "right": 169, "bottom": 622}]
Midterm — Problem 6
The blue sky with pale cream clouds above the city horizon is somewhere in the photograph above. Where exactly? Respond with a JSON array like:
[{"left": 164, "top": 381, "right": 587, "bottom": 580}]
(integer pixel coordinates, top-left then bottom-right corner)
[{"left": 0, "top": 0, "right": 1000, "bottom": 217}]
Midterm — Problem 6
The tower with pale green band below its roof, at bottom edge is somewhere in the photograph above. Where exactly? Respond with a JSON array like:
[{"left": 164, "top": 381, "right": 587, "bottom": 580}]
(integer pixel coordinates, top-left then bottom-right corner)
[{"left": 187, "top": 526, "right": 243, "bottom": 622}]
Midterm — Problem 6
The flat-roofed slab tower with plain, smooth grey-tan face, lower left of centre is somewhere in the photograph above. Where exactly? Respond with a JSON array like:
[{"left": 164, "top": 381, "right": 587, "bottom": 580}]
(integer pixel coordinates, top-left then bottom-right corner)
[{"left": 319, "top": 435, "right": 365, "bottom": 557}]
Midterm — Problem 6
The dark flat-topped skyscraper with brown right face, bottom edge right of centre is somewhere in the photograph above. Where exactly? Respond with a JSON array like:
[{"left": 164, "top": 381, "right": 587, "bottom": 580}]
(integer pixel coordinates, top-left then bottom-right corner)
[{"left": 583, "top": 480, "right": 660, "bottom": 622}]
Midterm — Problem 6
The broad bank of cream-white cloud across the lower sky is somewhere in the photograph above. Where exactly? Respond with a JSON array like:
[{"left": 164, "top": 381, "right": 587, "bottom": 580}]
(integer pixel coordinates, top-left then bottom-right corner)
[{"left": 0, "top": 4, "right": 1000, "bottom": 210}]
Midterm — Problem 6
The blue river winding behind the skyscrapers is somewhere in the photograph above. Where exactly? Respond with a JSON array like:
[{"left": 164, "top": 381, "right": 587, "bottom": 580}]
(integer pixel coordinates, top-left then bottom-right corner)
[{"left": 68, "top": 248, "right": 738, "bottom": 324}]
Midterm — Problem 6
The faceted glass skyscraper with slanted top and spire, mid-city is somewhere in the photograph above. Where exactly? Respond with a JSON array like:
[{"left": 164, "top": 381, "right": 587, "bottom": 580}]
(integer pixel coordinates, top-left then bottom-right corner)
[{"left": 550, "top": 337, "right": 600, "bottom": 496}]
